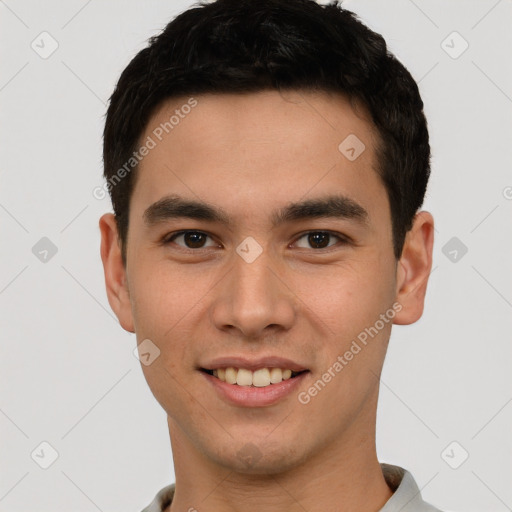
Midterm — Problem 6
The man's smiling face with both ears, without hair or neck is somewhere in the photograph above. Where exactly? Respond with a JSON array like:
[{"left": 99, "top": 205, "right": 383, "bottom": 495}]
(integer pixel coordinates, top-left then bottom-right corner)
[{"left": 100, "top": 91, "right": 431, "bottom": 473}]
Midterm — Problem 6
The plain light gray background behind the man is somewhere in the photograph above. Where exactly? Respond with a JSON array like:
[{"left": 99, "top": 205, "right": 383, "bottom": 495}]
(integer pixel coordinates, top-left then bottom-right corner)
[{"left": 0, "top": 0, "right": 512, "bottom": 512}]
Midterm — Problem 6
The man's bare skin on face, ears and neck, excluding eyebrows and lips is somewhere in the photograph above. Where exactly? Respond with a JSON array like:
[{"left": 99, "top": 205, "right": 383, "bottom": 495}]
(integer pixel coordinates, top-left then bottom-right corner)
[{"left": 100, "top": 91, "right": 434, "bottom": 512}]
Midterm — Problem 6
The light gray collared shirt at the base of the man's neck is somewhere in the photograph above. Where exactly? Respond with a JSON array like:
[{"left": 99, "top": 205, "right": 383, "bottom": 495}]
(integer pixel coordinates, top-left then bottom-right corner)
[{"left": 142, "top": 464, "right": 441, "bottom": 512}]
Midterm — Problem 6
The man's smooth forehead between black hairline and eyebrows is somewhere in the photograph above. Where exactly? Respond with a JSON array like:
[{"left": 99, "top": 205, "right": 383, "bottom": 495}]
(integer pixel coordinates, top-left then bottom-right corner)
[{"left": 133, "top": 91, "right": 386, "bottom": 224}]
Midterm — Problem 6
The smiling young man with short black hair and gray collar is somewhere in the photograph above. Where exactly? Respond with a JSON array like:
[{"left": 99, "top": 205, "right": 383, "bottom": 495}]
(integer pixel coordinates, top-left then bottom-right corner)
[{"left": 100, "top": 0, "right": 444, "bottom": 512}]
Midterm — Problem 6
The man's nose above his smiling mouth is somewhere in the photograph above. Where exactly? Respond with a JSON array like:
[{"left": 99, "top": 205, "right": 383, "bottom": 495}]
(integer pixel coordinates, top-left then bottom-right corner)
[{"left": 212, "top": 247, "right": 297, "bottom": 340}]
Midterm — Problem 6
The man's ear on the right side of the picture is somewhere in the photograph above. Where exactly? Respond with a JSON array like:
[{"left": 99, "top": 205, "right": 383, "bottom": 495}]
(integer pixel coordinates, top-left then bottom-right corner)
[{"left": 393, "top": 211, "right": 434, "bottom": 325}]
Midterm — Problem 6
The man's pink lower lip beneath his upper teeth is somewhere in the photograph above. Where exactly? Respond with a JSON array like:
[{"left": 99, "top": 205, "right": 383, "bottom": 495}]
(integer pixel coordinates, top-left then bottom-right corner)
[{"left": 201, "top": 371, "right": 309, "bottom": 407}]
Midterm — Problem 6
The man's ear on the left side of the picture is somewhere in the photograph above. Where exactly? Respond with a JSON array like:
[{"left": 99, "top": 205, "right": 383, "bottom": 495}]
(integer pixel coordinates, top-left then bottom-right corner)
[{"left": 99, "top": 213, "right": 135, "bottom": 332}]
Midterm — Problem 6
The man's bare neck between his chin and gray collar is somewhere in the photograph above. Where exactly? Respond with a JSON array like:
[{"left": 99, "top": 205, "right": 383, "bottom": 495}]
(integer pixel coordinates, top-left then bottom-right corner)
[{"left": 168, "top": 412, "right": 392, "bottom": 512}]
